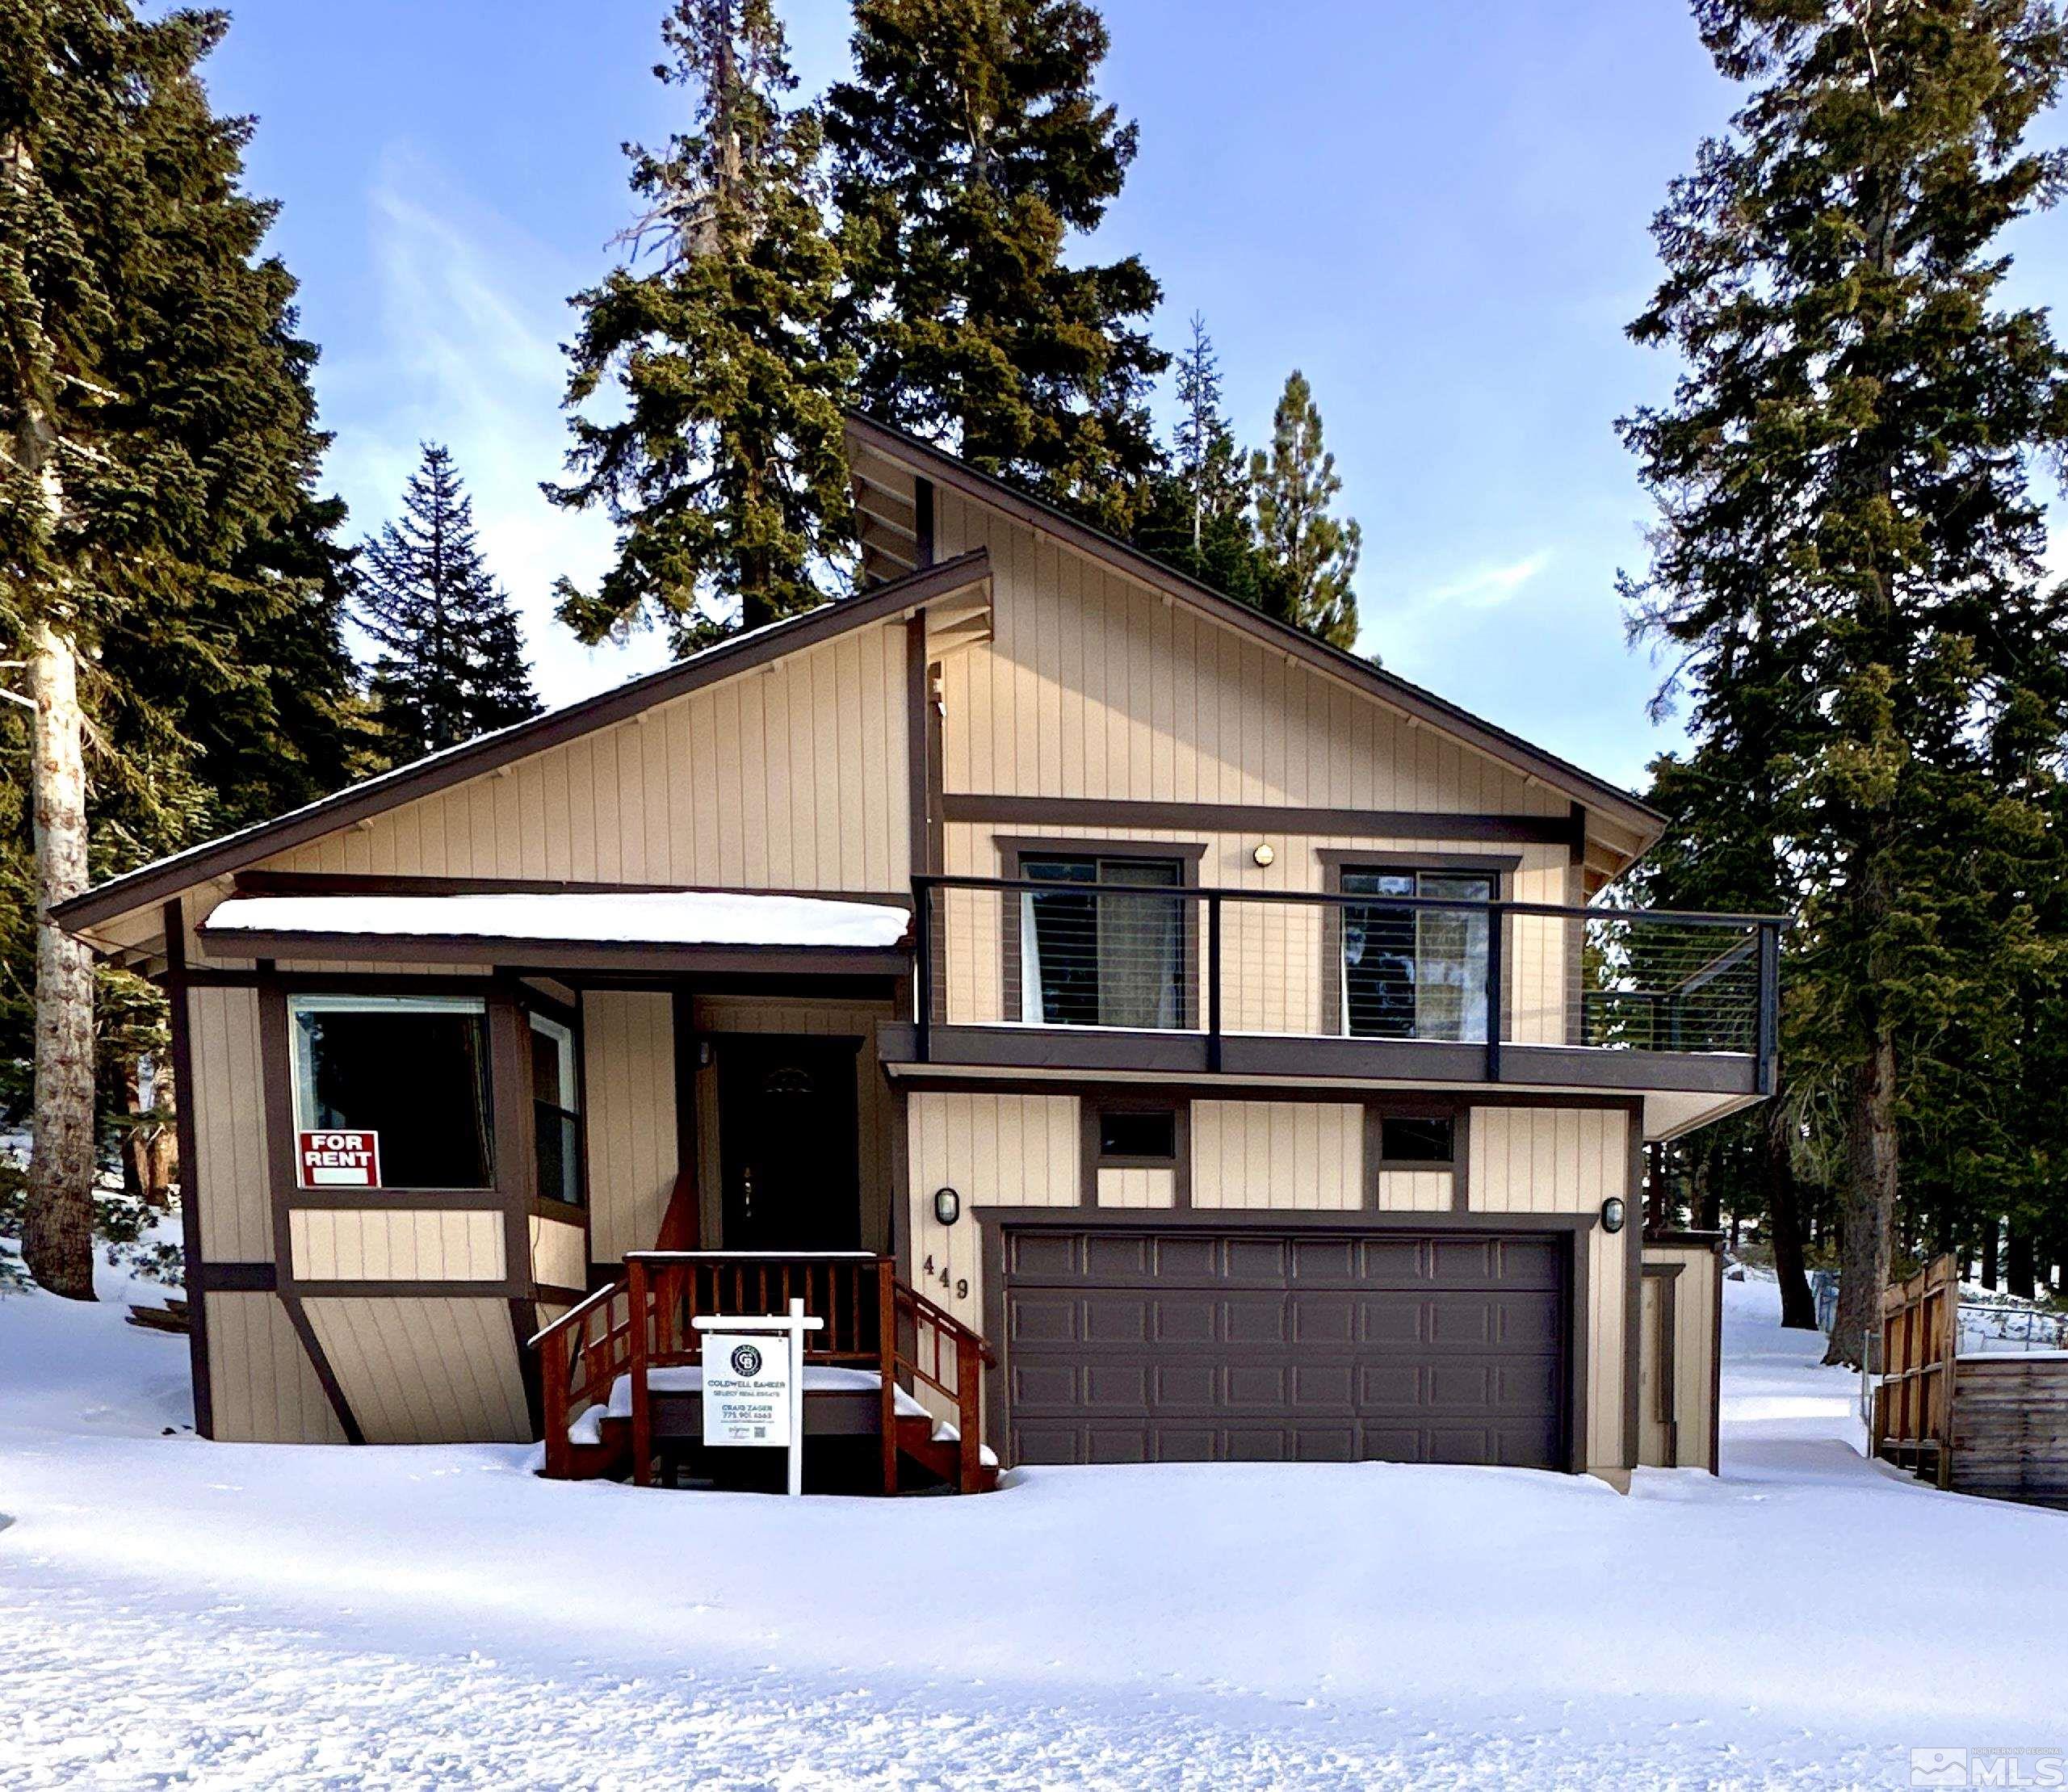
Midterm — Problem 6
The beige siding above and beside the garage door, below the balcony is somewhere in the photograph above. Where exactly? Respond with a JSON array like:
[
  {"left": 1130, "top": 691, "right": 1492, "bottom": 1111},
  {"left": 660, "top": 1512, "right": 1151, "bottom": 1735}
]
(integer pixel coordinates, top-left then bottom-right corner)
[{"left": 908, "top": 1090, "right": 1636, "bottom": 1473}]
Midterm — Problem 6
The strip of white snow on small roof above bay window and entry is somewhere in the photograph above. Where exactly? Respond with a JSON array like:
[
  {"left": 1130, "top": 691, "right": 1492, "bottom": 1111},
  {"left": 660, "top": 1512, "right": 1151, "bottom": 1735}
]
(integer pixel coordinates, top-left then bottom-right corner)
[{"left": 207, "top": 890, "right": 912, "bottom": 948}]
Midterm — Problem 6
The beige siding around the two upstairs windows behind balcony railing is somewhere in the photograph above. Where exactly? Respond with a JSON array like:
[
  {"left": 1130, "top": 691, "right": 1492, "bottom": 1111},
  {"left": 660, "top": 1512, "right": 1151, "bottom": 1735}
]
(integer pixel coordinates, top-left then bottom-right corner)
[{"left": 935, "top": 821, "right": 1580, "bottom": 1045}]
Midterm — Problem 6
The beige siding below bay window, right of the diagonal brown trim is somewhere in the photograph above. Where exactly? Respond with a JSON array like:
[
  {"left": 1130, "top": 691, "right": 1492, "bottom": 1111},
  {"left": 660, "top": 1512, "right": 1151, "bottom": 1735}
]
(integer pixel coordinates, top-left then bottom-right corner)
[{"left": 304, "top": 1295, "right": 531, "bottom": 1445}]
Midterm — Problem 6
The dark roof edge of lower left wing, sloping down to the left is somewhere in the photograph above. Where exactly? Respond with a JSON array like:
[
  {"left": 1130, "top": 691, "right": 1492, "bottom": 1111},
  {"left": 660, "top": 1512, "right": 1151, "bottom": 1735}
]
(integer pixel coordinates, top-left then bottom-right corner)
[{"left": 52, "top": 548, "right": 991, "bottom": 934}]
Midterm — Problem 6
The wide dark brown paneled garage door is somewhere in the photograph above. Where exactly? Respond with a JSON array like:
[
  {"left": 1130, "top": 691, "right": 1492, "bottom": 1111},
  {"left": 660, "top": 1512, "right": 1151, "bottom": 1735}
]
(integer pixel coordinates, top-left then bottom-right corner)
[{"left": 1003, "top": 1223, "right": 1571, "bottom": 1469}]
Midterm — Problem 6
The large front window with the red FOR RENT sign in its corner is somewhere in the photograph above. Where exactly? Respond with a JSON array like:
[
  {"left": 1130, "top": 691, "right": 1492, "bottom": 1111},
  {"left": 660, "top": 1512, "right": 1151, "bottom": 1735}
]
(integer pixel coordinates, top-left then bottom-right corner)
[{"left": 287, "top": 995, "right": 494, "bottom": 1188}]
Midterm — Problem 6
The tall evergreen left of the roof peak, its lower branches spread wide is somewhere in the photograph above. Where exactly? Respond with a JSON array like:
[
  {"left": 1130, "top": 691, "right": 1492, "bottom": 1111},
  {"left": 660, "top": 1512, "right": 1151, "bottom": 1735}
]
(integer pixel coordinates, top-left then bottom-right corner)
[{"left": 546, "top": 0, "right": 854, "bottom": 652}]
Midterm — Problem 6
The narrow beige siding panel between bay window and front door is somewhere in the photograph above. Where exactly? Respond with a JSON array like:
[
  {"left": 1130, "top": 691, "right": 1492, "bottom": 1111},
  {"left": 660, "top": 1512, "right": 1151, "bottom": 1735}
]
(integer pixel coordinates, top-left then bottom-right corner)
[{"left": 581, "top": 989, "right": 676, "bottom": 1265}]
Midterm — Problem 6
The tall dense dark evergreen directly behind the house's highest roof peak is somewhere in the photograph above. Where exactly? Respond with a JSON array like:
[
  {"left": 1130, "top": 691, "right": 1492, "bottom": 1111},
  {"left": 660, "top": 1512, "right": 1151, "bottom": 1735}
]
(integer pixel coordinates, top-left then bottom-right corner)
[{"left": 827, "top": 0, "right": 1168, "bottom": 536}]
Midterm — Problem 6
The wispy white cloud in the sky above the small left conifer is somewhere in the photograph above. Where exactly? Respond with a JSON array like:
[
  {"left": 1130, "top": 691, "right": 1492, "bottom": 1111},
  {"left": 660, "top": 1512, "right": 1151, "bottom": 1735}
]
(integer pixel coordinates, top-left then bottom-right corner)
[{"left": 327, "top": 147, "right": 666, "bottom": 703}]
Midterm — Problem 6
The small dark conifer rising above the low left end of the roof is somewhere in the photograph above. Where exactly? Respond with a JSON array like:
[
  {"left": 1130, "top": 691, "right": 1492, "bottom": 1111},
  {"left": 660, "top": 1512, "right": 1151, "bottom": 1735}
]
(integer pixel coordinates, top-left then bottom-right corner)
[{"left": 355, "top": 443, "right": 538, "bottom": 762}]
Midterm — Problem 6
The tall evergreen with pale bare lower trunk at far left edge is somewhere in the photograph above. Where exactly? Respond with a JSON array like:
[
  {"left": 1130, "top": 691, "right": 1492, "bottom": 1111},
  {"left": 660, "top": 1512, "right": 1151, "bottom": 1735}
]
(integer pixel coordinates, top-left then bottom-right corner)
[{"left": 0, "top": 0, "right": 358, "bottom": 1299}]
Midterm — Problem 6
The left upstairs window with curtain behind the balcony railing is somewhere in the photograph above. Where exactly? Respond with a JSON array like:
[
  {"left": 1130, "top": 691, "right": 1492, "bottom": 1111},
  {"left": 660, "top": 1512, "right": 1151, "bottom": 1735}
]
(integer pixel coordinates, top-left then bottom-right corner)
[{"left": 1020, "top": 854, "right": 1187, "bottom": 1026}]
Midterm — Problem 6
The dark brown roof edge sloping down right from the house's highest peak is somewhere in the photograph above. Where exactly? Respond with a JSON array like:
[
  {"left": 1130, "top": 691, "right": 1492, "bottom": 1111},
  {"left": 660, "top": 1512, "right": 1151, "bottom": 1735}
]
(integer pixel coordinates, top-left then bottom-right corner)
[{"left": 848, "top": 412, "right": 1667, "bottom": 844}]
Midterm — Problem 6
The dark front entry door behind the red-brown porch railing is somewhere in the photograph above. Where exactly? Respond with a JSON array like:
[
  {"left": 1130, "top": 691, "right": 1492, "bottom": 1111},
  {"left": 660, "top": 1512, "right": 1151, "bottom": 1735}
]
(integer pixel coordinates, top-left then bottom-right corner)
[{"left": 718, "top": 1034, "right": 862, "bottom": 1250}]
